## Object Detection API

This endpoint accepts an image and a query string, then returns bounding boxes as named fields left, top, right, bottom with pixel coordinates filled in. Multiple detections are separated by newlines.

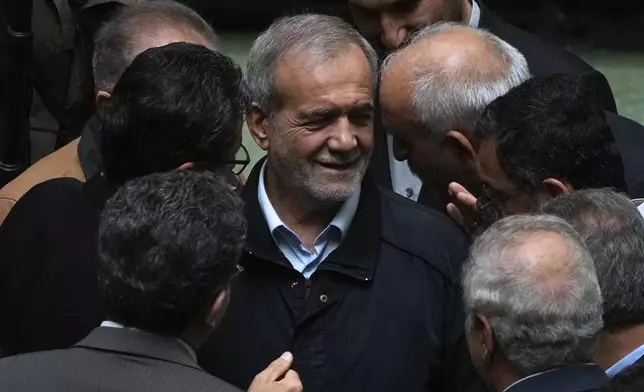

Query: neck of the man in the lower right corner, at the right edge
left=595, top=325, right=644, bottom=370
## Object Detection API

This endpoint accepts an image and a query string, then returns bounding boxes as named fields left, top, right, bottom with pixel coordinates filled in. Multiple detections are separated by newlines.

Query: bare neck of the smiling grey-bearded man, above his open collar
left=264, top=166, right=342, bottom=247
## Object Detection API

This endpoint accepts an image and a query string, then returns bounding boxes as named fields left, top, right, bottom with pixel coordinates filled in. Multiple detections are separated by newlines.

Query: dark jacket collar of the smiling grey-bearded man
left=242, top=158, right=382, bottom=281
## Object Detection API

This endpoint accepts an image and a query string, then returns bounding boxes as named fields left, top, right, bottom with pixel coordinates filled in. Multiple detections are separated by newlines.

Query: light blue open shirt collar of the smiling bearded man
left=257, top=163, right=360, bottom=279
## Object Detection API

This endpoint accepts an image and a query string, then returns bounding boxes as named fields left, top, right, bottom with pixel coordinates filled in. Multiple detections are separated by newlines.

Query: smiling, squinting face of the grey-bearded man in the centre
left=260, top=47, right=374, bottom=201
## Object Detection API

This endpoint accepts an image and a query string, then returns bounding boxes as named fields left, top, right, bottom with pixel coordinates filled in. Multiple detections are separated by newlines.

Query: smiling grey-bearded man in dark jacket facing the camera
left=201, top=14, right=484, bottom=392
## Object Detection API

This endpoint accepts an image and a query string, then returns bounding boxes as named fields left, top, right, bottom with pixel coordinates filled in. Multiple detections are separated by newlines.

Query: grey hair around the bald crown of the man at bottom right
left=463, top=215, right=602, bottom=375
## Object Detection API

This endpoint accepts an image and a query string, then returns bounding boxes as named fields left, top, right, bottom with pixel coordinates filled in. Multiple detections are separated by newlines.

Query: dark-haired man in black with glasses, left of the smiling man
left=0, top=43, right=249, bottom=363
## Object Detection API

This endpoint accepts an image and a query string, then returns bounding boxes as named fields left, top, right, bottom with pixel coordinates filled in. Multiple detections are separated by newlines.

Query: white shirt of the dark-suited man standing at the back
left=387, top=0, right=481, bottom=201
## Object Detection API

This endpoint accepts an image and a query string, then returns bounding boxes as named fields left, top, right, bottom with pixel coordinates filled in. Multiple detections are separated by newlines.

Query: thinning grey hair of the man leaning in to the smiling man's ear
left=383, top=22, right=531, bottom=141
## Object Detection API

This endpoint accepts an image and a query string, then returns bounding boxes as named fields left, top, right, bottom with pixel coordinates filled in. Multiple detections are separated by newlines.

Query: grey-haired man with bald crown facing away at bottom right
left=463, top=215, right=606, bottom=392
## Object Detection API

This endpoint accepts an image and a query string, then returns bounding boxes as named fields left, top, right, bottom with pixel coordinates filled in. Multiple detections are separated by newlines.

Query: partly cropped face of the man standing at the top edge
left=349, top=0, right=463, bottom=50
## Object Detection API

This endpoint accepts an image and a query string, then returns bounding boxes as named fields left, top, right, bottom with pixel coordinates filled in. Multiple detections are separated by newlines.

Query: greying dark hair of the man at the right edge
left=542, top=189, right=644, bottom=331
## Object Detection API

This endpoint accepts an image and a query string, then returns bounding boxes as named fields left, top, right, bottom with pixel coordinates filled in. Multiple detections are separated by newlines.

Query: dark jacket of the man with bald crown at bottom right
left=505, top=363, right=608, bottom=392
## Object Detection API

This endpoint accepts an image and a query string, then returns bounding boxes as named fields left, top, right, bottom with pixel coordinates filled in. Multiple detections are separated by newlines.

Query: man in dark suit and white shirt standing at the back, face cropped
left=349, top=0, right=617, bottom=200
